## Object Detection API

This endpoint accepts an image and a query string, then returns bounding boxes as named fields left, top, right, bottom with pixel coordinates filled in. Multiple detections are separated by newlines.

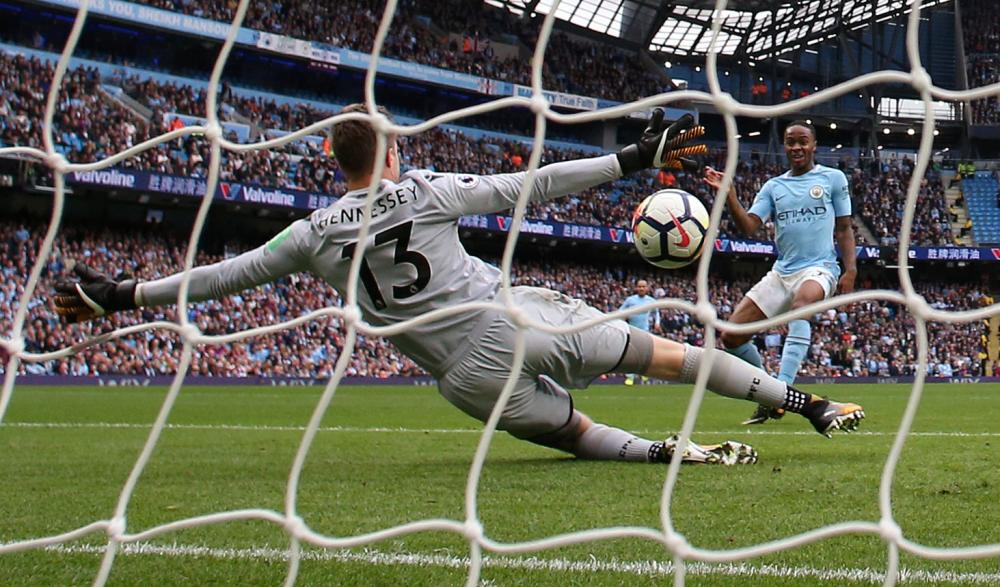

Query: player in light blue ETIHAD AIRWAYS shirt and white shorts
left=705, top=120, right=860, bottom=424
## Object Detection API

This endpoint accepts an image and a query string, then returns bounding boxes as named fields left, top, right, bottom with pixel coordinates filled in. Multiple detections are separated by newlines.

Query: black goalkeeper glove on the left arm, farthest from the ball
left=55, top=263, right=139, bottom=322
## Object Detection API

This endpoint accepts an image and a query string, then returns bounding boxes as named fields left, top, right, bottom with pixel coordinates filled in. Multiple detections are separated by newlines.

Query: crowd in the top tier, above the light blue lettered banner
left=129, top=0, right=671, bottom=102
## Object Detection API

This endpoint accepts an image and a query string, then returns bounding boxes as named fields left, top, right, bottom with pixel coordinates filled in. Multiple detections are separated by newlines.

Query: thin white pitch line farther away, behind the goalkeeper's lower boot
left=0, top=422, right=1000, bottom=438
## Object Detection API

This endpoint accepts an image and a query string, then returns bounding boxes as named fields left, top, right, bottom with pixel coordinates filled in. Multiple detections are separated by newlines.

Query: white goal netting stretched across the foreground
left=0, top=0, right=1000, bottom=585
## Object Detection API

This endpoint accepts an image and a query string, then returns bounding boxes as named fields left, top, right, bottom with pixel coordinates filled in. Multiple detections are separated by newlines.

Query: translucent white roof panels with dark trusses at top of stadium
left=485, top=0, right=950, bottom=59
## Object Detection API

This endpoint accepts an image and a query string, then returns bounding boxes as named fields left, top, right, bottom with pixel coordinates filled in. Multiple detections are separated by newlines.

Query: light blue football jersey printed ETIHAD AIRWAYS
left=749, top=165, right=851, bottom=277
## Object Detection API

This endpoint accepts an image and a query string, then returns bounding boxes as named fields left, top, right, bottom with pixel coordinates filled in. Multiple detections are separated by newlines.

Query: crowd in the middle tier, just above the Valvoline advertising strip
left=0, top=54, right=953, bottom=250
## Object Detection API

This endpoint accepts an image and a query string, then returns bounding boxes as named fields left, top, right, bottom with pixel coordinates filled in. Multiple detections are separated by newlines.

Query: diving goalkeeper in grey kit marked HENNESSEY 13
left=55, top=104, right=864, bottom=464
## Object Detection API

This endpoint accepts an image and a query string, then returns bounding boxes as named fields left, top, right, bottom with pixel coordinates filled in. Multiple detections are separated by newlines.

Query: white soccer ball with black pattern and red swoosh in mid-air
left=632, top=189, right=709, bottom=269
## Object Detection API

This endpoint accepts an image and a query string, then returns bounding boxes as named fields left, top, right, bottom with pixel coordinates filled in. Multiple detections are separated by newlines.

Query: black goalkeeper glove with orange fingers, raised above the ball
left=618, top=108, right=708, bottom=175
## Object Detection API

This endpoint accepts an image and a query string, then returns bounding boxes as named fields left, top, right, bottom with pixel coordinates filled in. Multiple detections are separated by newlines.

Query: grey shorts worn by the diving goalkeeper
left=438, top=287, right=630, bottom=438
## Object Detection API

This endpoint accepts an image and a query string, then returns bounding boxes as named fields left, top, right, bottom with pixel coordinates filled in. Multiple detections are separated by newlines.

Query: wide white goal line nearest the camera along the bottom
left=31, top=543, right=1000, bottom=585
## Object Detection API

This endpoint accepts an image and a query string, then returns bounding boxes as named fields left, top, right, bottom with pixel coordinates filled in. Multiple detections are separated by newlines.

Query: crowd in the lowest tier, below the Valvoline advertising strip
left=0, top=221, right=988, bottom=377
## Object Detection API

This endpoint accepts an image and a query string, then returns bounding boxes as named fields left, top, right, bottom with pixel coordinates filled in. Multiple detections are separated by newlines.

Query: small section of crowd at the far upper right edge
left=962, top=0, right=1000, bottom=125
